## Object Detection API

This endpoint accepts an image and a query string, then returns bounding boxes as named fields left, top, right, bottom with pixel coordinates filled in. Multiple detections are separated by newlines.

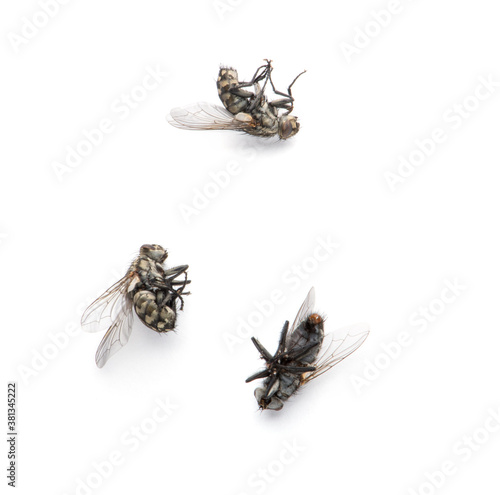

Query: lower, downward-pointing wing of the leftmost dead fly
left=95, top=296, right=133, bottom=368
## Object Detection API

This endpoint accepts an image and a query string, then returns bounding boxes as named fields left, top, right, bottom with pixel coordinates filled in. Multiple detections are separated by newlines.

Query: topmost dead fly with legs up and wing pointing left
left=167, top=60, right=305, bottom=139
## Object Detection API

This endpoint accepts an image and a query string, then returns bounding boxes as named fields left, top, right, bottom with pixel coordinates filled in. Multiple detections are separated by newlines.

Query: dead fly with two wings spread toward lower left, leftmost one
left=82, top=244, right=191, bottom=368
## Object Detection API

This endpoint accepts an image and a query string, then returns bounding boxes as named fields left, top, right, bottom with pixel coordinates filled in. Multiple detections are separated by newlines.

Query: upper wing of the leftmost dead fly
left=81, top=273, right=135, bottom=332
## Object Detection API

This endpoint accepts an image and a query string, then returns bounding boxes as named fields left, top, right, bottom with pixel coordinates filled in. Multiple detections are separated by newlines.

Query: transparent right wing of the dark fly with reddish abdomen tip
left=303, top=323, right=370, bottom=383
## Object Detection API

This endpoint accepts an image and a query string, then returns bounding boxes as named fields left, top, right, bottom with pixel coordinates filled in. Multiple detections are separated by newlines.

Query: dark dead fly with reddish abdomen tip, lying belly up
left=246, top=288, right=369, bottom=411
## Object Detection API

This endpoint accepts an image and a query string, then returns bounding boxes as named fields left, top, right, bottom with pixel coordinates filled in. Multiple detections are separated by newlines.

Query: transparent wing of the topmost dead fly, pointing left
left=167, top=102, right=253, bottom=131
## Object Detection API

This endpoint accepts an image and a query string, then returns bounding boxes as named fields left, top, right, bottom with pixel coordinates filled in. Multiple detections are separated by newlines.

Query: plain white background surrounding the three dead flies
left=0, top=0, right=500, bottom=495
